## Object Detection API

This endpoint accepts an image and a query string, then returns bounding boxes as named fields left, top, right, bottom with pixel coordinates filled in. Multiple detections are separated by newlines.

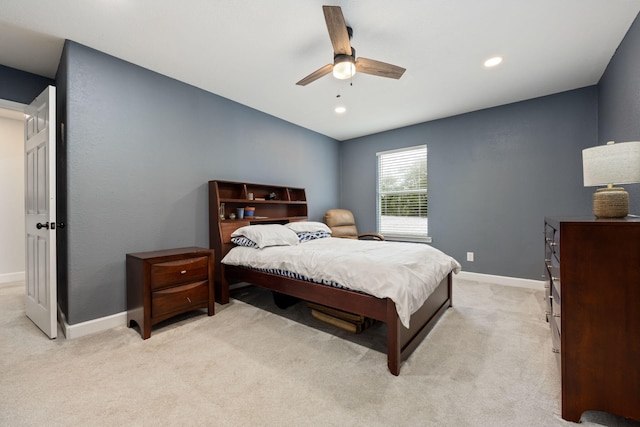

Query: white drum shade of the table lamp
left=582, top=141, right=640, bottom=187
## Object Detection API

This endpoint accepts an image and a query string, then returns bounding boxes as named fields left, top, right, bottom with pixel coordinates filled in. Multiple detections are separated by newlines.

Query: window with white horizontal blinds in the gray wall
left=377, top=145, right=431, bottom=242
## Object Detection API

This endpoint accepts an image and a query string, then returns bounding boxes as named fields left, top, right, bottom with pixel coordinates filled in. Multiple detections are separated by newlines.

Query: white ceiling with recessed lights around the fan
left=0, top=0, right=640, bottom=140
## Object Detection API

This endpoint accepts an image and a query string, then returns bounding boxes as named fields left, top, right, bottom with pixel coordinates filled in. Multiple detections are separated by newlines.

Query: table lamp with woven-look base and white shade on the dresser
left=582, top=141, right=640, bottom=218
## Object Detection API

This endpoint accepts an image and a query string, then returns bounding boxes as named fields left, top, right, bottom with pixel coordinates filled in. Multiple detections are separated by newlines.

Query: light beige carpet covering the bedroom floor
left=0, top=280, right=636, bottom=426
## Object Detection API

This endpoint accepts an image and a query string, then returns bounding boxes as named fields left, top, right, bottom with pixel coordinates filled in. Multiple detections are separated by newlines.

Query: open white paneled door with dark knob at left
left=24, top=86, right=58, bottom=338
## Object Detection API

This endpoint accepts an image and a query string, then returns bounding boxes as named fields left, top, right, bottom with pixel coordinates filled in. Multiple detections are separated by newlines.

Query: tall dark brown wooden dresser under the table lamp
left=545, top=218, right=640, bottom=422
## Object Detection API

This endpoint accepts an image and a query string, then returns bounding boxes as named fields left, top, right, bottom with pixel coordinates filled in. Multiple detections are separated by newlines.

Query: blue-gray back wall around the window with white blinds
left=340, top=86, right=597, bottom=279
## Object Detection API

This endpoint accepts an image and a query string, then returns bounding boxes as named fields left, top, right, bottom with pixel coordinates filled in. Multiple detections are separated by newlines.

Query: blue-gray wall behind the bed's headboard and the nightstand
left=58, top=42, right=339, bottom=324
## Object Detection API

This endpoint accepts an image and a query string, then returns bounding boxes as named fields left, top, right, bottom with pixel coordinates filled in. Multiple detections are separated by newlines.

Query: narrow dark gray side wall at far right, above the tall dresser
left=598, top=15, right=640, bottom=215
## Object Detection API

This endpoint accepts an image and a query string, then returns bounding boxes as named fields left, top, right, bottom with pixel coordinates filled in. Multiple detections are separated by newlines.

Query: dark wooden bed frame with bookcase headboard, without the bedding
left=209, top=181, right=452, bottom=375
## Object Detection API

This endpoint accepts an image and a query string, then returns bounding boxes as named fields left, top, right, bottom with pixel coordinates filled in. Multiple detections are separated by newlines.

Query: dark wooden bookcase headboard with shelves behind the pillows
left=209, top=180, right=308, bottom=303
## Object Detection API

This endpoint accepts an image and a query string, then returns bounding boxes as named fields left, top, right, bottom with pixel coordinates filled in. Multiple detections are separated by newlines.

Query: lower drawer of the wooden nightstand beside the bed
left=151, top=280, right=209, bottom=318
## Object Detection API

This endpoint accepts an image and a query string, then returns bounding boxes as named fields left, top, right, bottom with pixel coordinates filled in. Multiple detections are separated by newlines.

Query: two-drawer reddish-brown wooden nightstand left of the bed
left=127, top=247, right=215, bottom=339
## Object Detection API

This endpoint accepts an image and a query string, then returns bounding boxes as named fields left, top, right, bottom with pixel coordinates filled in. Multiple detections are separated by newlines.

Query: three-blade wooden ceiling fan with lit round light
left=296, top=6, right=405, bottom=86
